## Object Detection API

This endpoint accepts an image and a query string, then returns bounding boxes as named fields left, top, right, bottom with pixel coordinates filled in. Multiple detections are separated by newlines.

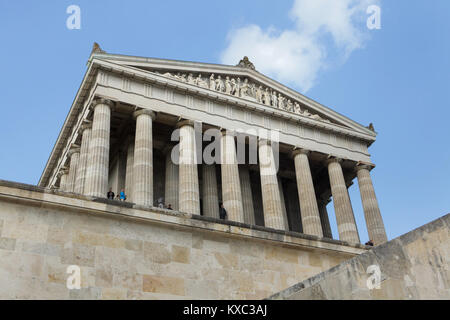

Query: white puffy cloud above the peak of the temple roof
left=221, top=0, right=378, bottom=92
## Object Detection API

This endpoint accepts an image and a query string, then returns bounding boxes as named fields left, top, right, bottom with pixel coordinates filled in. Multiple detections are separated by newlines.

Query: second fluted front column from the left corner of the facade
left=133, top=109, right=155, bottom=206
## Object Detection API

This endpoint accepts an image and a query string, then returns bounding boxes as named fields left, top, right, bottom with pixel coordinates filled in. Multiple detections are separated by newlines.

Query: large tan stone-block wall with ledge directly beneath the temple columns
left=0, top=180, right=367, bottom=299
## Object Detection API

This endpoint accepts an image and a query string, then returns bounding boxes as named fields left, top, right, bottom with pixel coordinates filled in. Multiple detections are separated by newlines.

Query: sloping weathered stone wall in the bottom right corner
left=270, top=214, right=450, bottom=300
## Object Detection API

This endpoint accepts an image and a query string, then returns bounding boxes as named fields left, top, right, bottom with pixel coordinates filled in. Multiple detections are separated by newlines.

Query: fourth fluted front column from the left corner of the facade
left=220, top=130, right=244, bottom=222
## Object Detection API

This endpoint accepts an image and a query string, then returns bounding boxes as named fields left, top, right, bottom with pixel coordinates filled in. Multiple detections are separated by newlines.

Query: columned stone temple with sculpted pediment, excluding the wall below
left=39, top=45, right=387, bottom=245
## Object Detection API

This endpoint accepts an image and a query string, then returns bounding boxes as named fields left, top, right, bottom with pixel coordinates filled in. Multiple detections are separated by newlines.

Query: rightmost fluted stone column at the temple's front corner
left=356, top=164, right=387, bottom=245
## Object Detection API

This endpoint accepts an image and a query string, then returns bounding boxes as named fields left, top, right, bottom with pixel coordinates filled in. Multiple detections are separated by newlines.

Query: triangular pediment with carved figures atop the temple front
left=91, top=52, right=376, bottom=136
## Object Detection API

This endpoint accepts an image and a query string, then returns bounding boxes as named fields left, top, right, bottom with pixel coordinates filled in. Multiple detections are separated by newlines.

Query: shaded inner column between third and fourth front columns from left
left=202, top=163, right=219, bottom=219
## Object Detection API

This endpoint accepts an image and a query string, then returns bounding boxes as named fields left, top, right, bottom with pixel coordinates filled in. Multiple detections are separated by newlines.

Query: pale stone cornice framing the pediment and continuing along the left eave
left=38, top=52, right=376, bottom=186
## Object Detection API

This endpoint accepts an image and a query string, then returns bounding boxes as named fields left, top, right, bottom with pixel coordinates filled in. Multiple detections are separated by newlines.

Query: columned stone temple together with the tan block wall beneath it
left=0, top=44, right=394, bottom=299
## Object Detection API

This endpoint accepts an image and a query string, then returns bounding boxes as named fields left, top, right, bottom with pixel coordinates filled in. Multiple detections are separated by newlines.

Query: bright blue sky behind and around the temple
left=0, top=0, right=450, bottom=242
